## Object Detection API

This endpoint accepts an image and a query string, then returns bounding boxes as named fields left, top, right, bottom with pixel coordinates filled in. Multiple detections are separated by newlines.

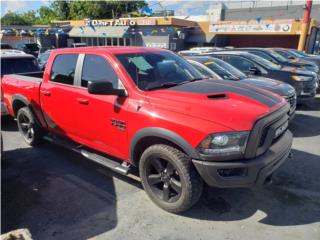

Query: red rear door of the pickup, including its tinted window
left=40, top=54, right=79, bottom=138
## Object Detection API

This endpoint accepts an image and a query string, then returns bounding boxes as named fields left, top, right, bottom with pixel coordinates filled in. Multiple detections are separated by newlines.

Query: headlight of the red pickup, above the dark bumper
left=198, top=132, right=249, bottom=156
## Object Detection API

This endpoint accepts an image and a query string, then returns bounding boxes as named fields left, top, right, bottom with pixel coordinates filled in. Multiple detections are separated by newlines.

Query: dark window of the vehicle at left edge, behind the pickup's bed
left=1, top=58, right=40, bottom=75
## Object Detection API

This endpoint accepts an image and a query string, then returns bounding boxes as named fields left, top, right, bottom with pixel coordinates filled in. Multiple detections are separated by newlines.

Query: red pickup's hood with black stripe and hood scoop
left=147, top=79, right=285, bottom=131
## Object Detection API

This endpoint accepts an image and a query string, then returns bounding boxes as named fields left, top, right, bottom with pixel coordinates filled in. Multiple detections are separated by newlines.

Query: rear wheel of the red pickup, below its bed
left=17, top=107, right=43, bottom=146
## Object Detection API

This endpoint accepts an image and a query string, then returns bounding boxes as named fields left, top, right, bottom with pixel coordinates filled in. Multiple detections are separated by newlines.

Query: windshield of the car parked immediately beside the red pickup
left=203, top=59, right=246, bottom=80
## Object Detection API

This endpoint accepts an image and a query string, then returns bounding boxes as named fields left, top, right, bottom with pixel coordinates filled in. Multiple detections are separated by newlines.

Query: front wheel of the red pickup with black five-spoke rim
left=139, top=144, right=203, bottom=213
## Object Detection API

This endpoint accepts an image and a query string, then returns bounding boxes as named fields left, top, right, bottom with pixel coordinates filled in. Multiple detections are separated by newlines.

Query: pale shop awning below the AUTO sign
left=69, top=26, right=129, bottom=38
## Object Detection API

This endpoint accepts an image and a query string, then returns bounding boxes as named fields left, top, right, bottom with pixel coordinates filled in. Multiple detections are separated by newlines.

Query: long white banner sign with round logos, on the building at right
left=209, top=23, right=292, bottom=33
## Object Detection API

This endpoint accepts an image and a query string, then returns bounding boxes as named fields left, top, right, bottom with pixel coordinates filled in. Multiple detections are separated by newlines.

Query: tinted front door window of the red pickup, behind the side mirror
left=81, top=55, right=119, bottom=88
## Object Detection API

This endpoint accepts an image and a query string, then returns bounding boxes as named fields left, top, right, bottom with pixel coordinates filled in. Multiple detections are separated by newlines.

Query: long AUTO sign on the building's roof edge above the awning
left=84, top=18, right=156, bottom=27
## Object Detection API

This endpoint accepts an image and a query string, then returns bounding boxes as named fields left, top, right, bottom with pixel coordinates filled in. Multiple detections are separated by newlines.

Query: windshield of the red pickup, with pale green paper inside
left=115, top=51, right=203, bottom=91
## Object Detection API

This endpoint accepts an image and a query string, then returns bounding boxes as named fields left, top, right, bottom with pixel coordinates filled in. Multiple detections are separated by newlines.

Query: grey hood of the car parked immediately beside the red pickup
left=240, top=77, right=295, bottom=96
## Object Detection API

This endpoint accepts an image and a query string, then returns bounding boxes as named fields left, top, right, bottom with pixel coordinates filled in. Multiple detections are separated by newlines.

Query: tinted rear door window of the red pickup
left=50, top=54, right=78, bottom=85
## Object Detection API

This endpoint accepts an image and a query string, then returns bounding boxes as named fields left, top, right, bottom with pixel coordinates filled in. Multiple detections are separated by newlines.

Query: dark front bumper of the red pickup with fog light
left=192, top=130, right=292, bottom=188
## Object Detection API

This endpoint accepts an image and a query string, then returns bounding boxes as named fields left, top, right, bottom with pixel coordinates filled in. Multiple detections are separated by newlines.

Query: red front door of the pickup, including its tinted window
left=74, top=54, right=128, bottom=158
